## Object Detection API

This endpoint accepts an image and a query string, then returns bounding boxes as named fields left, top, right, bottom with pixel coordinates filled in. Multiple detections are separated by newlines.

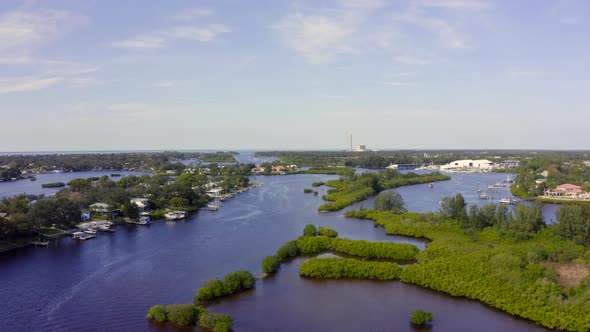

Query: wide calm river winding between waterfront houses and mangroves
left=0, top=175, right=552, bottom=331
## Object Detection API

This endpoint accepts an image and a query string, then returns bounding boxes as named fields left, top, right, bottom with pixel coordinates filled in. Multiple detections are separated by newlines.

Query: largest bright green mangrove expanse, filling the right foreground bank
left=347, top=200, right=590, bottom=331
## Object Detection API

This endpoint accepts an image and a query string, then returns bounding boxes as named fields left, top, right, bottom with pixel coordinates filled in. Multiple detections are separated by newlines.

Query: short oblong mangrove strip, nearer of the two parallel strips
left=299, top=258, right=402, bottom=280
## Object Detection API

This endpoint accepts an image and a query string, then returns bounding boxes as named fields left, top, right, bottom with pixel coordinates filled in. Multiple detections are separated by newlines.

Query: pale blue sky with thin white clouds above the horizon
left=0, top=0, right=590, bottom=151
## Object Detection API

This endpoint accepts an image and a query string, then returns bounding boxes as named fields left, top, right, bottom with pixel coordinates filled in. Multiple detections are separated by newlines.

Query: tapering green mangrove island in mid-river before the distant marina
left=319, top=169, right=451, bottom=212
